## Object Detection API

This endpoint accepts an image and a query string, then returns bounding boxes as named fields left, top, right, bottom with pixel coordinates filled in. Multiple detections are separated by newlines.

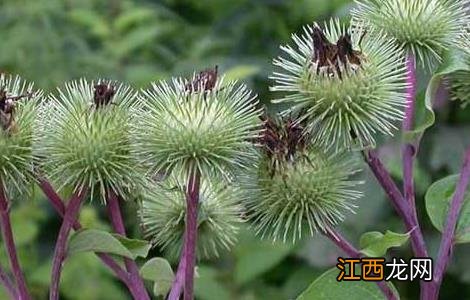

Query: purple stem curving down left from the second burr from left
left=49, top=187, right=87, bottom=300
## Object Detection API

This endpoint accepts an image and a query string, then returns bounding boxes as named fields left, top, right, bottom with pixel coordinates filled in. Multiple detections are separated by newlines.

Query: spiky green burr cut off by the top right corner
left=352, top=0, right=470, bottom=69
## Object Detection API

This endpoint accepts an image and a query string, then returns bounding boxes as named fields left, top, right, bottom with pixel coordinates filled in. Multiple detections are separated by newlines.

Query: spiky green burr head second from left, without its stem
left=40, top=79, right=143, bottom=201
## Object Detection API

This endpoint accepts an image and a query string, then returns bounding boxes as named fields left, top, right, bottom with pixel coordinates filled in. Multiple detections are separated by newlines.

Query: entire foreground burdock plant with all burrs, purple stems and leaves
left=0, top=0, right=470, bottom=300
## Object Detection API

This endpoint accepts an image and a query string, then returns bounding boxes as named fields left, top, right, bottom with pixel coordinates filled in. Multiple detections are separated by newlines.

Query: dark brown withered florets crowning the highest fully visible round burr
left=312, top=26, right=365, bottom=79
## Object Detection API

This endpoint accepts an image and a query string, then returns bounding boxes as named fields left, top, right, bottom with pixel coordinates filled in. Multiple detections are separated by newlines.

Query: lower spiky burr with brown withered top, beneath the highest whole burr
left=241, top=119, right=361, bottom=242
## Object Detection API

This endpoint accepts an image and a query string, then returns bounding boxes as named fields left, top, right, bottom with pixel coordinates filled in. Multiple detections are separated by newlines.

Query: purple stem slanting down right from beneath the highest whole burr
left=365, top=150, right=428, bottom=257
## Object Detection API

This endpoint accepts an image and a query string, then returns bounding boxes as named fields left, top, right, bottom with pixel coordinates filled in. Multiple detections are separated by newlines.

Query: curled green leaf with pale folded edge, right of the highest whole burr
left=403, top=49, right=468, bottom=145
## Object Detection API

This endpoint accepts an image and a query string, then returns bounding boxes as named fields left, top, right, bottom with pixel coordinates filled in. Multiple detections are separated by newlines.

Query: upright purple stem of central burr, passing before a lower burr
left=180, top=170, right=200, bottom=300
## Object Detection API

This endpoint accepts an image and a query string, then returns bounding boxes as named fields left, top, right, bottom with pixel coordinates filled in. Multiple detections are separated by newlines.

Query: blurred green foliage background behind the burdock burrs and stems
left=0, top=0, right=470, bottom=300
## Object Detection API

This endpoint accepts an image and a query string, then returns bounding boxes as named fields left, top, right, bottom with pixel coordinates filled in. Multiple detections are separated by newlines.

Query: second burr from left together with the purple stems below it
left=39, top=80, right=148, bottom=299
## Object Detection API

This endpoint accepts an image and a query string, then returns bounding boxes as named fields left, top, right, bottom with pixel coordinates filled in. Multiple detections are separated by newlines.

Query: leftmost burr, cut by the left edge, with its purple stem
left=0, top=74, right=42, bottom=299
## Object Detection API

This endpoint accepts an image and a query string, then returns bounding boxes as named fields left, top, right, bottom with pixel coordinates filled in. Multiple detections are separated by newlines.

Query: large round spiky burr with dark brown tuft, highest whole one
left=272, top=20, right=406, bottom=149
